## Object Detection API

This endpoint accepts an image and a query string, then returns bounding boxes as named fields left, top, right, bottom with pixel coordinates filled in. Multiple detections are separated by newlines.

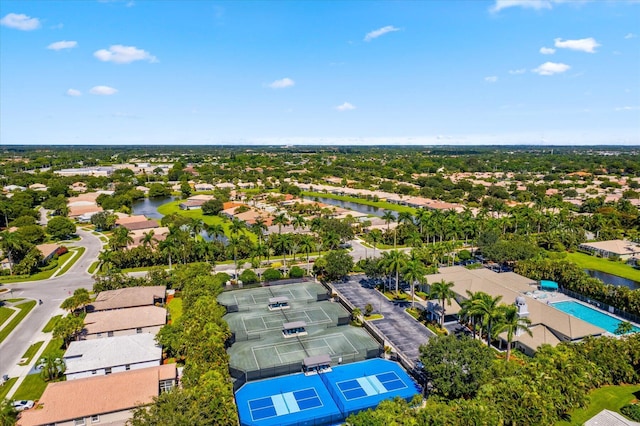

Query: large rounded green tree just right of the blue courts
left=420, top=335, right=494, bottom=399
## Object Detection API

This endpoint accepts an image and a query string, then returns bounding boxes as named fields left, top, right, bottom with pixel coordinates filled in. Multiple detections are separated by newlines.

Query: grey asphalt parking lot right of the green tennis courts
left=333, top=275, right=434, bottom=361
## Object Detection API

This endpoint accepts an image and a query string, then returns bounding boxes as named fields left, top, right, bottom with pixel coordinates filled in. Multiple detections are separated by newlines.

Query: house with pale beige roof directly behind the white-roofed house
left=82, top=306, right=167, bottom=340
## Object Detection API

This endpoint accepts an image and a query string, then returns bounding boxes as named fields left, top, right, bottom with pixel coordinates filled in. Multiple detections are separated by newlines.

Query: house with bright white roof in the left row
left=63, top=333, right=162, bottom=380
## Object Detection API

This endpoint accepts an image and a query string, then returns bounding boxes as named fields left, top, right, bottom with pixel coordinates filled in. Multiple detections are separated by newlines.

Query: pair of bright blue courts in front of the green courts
left=236, top=359, right=421, bottom=426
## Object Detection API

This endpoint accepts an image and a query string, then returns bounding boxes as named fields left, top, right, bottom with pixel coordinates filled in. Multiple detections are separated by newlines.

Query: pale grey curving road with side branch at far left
left=0, top=228, right=102, bottom=377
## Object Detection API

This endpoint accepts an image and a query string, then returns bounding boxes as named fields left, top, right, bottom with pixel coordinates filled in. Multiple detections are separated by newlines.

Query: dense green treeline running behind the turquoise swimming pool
left=515, top=259, right=640, bottom=316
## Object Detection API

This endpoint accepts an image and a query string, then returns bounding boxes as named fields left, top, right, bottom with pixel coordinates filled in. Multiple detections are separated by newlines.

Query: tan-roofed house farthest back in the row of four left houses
left=87, top=285, right=167, bottom=312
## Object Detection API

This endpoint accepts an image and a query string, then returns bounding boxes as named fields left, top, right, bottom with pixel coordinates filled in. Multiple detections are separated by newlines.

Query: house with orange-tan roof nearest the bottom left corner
left=17, top=364, right=178, bottom=426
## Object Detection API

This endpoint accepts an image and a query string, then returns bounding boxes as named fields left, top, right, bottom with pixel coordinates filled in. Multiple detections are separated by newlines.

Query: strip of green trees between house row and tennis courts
left=130, top=264, right=238, bottom=426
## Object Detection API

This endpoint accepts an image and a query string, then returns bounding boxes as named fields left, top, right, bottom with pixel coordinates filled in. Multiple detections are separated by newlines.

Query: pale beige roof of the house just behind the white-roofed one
left=84, top=306, right=167, bottom=334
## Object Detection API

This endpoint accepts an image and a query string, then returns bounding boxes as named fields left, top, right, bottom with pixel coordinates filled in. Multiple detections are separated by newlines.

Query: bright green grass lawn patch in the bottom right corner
left=557, top=385, right=640, bottom=426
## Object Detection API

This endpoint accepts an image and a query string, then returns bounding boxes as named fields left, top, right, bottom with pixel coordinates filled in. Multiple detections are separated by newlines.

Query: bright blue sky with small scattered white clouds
left=0, top=0, right=640, bottom=145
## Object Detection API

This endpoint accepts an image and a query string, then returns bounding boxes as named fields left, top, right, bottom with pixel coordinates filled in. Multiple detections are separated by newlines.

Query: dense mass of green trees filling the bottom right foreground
left=347, top=334, right=640, bottom=426
